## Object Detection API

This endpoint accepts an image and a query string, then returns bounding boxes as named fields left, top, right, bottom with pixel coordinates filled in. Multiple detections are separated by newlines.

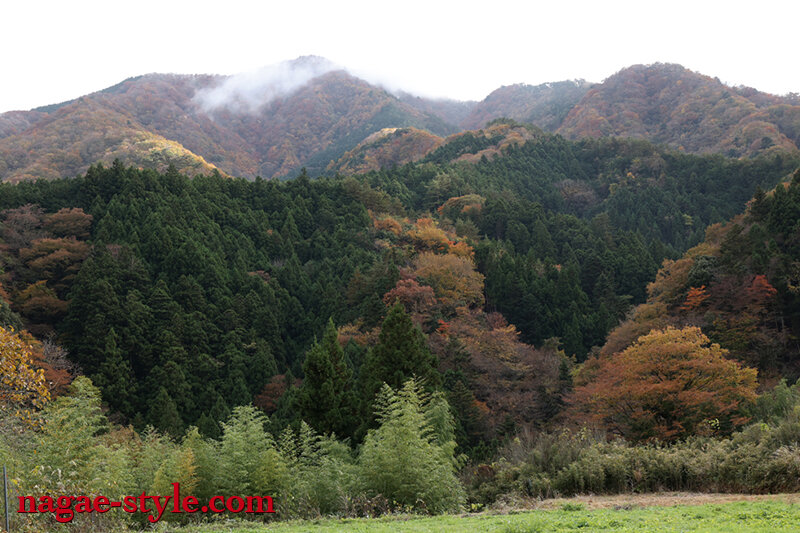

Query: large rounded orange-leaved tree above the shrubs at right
left=569, top=327, right=757, bottom=441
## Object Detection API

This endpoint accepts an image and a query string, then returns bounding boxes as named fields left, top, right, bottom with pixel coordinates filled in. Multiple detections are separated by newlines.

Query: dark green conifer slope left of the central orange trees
left=3, top=165, right=384, bottom=432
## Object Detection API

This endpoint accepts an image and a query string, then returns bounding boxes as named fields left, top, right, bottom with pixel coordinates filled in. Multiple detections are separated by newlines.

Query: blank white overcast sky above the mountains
left=0, top=0, right=800, bottom=112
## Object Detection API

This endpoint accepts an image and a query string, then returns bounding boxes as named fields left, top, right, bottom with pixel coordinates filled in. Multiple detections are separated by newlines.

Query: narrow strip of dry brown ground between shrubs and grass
left=525, top=492, right=800, bottom=509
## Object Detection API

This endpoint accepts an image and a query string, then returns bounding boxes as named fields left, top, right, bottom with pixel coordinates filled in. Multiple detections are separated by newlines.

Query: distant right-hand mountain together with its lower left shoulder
left=459, top=63, right=800, bottom=157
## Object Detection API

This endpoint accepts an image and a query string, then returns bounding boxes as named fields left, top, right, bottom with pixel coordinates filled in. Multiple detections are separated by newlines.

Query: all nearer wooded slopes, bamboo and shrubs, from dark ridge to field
left=0, top=141, right=800, bottom=530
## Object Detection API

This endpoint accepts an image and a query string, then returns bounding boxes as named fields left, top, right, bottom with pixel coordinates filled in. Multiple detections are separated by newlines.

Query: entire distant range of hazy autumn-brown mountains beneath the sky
left=0, top=57, right=800, bottom=181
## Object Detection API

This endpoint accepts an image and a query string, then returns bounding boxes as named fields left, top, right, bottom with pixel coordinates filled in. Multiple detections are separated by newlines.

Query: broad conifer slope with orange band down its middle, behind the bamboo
left=0, top=122, right=797, bottom=440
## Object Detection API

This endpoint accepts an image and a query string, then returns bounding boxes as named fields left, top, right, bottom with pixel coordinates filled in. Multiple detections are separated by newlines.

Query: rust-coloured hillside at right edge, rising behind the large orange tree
left=601, top=171, right=800, bottom=383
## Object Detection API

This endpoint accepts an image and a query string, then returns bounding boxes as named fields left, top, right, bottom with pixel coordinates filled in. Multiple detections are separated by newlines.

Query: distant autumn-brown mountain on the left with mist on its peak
left=0, top=58, right=459, bottom=181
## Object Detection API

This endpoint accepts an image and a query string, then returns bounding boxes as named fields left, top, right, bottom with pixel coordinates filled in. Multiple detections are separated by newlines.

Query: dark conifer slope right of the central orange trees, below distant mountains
left=365, top=128, right=798, bottom=356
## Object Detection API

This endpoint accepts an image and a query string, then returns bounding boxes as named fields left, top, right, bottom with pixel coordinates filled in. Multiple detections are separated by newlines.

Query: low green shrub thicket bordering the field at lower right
left=462, top=384, right=800, bottom=504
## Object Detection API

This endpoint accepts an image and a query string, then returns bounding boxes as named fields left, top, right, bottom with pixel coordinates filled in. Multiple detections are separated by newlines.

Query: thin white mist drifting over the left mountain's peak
left=194, top=56, right=340, bottom=112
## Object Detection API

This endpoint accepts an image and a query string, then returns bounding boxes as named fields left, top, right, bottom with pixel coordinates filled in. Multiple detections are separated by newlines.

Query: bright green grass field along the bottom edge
left=156, top=500, right=800, bottom=533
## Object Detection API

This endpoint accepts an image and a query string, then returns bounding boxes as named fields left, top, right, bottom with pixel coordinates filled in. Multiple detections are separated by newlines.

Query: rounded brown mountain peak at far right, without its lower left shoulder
left=557, top=63, right=800, bottom=157
